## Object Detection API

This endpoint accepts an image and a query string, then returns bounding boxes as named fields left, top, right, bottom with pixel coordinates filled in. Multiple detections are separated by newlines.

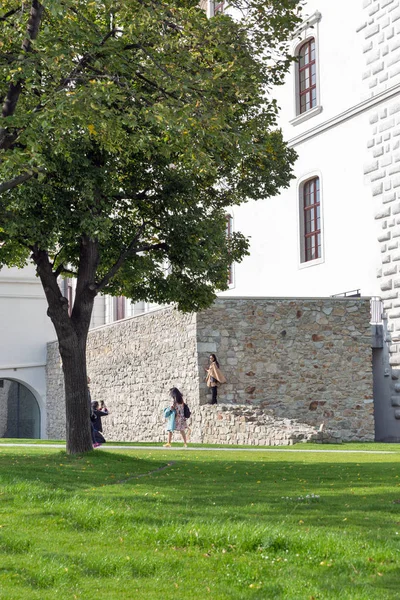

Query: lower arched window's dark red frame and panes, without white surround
left=300, top=177, right=322, bottom=262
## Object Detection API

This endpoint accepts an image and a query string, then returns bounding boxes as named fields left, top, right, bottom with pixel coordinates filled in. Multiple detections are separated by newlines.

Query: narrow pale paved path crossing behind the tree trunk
left=0, top=443, right=400, bottom=454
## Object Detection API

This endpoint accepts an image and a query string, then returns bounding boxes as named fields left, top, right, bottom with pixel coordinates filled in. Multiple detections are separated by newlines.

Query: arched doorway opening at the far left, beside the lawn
left=0, top=379, right=40, bottom=439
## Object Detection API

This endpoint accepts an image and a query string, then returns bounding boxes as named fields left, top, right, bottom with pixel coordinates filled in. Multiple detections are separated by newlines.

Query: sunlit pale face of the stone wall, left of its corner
left=47, top=308, right=199, bottom=441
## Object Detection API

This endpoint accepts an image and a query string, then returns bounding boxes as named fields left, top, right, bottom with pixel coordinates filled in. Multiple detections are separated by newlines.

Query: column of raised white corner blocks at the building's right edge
left=357, top=0, right=400, bottom=366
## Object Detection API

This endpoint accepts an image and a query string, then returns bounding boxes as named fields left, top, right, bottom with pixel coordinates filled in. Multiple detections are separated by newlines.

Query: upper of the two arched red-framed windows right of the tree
left=298, top=38, right=317, bottom=114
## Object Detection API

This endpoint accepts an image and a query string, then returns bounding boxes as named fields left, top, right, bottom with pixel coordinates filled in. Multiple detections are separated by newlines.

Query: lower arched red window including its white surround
left=299, top=176, right=322, bottom=265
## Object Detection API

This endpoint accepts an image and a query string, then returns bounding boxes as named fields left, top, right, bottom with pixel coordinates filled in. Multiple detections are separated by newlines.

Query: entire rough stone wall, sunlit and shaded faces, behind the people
left=47, top=298, right=374, bottom=445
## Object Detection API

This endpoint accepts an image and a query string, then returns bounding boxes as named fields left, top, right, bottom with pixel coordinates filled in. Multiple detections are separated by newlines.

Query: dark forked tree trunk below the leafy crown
left=32, top=238, right=98, bottom=454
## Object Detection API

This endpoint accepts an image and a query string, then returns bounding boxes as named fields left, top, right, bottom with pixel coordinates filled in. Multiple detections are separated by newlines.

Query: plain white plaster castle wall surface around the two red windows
left=223, top=0, right=386, bottom=296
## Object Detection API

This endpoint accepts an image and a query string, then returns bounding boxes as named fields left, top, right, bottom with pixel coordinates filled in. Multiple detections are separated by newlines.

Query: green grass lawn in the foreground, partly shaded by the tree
left=0, top=444, right=400, bottom=600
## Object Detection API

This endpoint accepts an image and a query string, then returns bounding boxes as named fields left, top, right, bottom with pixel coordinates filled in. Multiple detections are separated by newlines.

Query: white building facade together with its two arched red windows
left=222, top=0, right=390, bottom=296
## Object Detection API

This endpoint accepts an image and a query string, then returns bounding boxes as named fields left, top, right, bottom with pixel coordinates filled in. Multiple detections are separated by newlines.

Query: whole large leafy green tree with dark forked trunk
left=0, top=0, right=299, bottom=453
